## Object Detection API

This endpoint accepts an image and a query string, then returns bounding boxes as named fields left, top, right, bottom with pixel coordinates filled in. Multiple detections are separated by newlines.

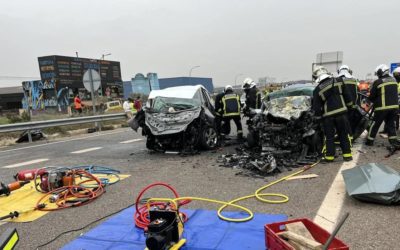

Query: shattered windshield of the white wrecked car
left=153, top=96, right=201, bottom=112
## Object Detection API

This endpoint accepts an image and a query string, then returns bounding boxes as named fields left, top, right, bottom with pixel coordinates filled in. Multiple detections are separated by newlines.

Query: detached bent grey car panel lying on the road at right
left=342, top=163, right=400, bottom=205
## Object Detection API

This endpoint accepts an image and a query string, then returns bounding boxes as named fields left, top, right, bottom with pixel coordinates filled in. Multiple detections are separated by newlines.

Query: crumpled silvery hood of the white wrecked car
left=145, top=107, right=201, bottom=135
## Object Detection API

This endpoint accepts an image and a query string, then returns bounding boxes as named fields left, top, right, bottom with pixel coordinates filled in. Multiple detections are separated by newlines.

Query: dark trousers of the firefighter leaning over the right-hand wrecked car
left=323, top=114, right=352, bottom=160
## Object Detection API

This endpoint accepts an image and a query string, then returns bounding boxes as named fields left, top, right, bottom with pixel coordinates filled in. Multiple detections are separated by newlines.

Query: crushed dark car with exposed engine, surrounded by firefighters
left=242, top=84, right=368, bottom=167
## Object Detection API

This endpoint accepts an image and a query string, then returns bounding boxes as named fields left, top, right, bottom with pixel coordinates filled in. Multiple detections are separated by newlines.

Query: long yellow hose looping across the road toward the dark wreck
left=147, top=161, right=319, bottom=222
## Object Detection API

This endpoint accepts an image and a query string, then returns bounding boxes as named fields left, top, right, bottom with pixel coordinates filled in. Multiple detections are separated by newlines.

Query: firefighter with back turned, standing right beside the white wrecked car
left=221, top=85, right=243, bottom=140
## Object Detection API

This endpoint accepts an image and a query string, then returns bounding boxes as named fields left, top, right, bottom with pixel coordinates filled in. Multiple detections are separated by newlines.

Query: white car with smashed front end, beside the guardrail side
left=129, top=85, right=217, bottom=152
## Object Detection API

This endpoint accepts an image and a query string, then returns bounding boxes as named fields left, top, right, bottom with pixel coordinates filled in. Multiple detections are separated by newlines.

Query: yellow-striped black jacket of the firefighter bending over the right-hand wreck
left=312, top=77, right=351, bottom=117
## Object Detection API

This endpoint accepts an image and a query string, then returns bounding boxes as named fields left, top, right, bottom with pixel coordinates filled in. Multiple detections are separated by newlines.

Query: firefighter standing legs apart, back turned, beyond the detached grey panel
left=365, top=64, right=399, bottom=146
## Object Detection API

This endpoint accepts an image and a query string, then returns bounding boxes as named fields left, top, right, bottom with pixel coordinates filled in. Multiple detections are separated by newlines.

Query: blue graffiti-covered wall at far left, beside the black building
left=22, top=80, right=69, bottom=111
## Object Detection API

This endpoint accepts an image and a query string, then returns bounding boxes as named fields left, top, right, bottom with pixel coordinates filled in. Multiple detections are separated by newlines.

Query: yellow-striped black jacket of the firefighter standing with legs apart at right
left=369, top=76, right=399, bottom=111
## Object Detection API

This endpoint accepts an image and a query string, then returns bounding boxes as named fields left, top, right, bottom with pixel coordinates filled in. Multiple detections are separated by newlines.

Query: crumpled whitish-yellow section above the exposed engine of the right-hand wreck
left=264, top=96, right=311, bottom=120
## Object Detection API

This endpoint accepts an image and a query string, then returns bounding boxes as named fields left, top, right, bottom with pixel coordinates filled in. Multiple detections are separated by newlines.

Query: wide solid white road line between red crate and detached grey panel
left=314, top=144, right=362, bottom=232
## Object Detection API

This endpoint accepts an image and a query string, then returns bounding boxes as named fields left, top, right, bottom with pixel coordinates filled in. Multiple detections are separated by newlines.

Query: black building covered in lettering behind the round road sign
left=38, top=55, right=122, bottom=99
